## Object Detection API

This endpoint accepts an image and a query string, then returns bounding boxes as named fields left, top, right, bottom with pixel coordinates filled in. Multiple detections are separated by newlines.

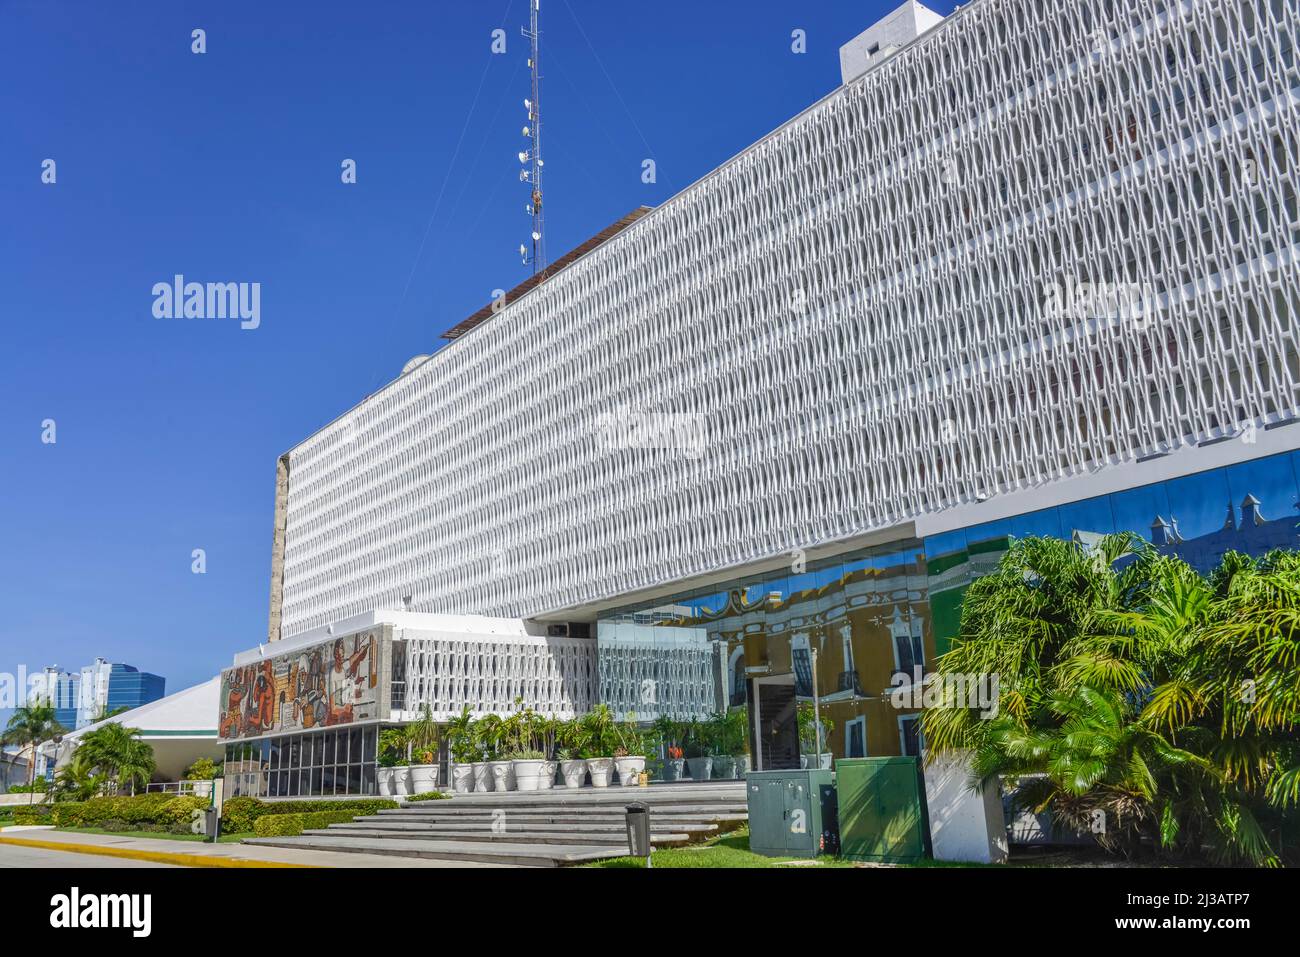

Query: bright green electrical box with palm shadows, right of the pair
left=835, top=758, right=930, bottom=863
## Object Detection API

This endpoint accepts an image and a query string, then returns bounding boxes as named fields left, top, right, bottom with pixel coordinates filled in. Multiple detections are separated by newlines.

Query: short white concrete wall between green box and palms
left=924, top=757, right=1008, bottom=863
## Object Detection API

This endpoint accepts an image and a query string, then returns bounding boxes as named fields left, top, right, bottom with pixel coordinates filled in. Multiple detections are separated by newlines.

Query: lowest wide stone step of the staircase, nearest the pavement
left=243, top=835, right=620, bottom=867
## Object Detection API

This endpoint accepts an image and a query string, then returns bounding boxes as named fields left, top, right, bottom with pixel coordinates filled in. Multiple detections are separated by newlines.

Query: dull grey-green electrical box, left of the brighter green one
left=745, top=770, right=835, bottom=857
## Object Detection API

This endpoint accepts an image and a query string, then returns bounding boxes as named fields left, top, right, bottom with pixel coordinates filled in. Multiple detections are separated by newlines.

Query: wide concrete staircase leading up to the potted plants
left=244, top=781, right=749, bottom=867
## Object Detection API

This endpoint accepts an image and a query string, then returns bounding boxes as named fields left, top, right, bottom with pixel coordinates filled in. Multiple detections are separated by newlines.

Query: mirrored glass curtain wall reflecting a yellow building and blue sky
left=597, top=452, right=1300, bottom=758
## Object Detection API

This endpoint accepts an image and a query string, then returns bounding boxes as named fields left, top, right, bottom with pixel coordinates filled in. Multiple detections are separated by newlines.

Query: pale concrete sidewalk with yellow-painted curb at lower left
left=0, top=828, right=514, bottom=867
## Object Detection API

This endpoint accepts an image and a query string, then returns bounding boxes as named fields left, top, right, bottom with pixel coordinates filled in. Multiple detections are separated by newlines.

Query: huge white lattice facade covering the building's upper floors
left=281, top=0, right=1300, bottom=642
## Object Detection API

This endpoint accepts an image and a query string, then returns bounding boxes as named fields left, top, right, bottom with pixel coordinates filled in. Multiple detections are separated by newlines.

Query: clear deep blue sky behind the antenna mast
left=0, top=0, right=953, bottom=718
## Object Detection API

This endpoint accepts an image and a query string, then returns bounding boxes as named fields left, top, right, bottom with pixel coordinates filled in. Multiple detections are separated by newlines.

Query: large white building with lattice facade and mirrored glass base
left=222, top=0, right=1300, bottom=790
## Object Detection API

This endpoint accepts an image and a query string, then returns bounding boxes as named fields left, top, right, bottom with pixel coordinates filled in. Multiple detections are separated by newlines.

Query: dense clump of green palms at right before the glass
left=923, top=536, right=1300, bottom=865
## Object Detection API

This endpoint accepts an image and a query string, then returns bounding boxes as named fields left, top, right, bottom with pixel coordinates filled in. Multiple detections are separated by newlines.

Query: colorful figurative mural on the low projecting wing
left=217, top=632, right=381, bottom=740
